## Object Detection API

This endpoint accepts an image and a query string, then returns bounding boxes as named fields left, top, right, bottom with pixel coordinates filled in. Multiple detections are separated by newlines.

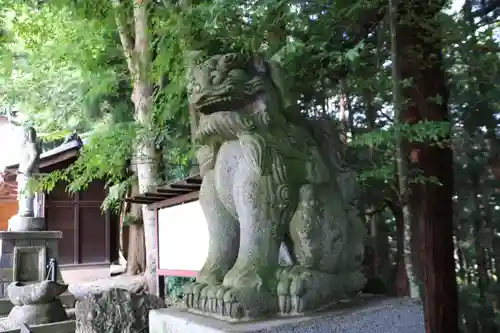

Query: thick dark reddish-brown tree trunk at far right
left=397, top=0, right=458, bottom=333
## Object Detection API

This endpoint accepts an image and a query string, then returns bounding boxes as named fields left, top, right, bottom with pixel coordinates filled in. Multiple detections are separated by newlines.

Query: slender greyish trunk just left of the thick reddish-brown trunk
left=389, top=0, right=420, bottom=298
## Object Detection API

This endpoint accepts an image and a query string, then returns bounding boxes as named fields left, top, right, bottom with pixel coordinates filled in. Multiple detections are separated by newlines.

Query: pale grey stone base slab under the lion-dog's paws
left=149, top=297, right=425, bottom=333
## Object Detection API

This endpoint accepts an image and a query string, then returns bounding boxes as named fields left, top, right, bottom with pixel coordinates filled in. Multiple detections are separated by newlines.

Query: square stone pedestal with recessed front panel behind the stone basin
left=0, top=231, right=62, bottom=298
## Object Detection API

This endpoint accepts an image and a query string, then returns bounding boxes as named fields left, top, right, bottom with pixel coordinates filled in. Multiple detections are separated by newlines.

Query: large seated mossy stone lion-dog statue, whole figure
left=185, top=54, right=365, bottom=321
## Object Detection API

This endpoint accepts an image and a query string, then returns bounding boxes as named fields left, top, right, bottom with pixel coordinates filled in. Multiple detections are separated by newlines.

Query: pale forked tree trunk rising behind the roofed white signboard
left=113, top=0, right=158, bottom=293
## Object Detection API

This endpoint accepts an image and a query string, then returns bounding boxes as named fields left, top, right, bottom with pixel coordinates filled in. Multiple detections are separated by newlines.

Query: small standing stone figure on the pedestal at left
left=17, top=127, right=40, bottom=217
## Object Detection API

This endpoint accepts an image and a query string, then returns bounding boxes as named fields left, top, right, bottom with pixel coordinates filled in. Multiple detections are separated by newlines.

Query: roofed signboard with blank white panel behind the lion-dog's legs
left=125, top=175, right=204, bottom=297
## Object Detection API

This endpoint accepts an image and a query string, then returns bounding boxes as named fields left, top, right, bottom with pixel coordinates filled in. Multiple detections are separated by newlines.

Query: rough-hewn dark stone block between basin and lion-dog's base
left=75, top=289, right=165, bottom=333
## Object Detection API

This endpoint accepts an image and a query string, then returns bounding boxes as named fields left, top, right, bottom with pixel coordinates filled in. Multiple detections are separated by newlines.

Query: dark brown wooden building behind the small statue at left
left=4, top=139, right=119, bottom=268
